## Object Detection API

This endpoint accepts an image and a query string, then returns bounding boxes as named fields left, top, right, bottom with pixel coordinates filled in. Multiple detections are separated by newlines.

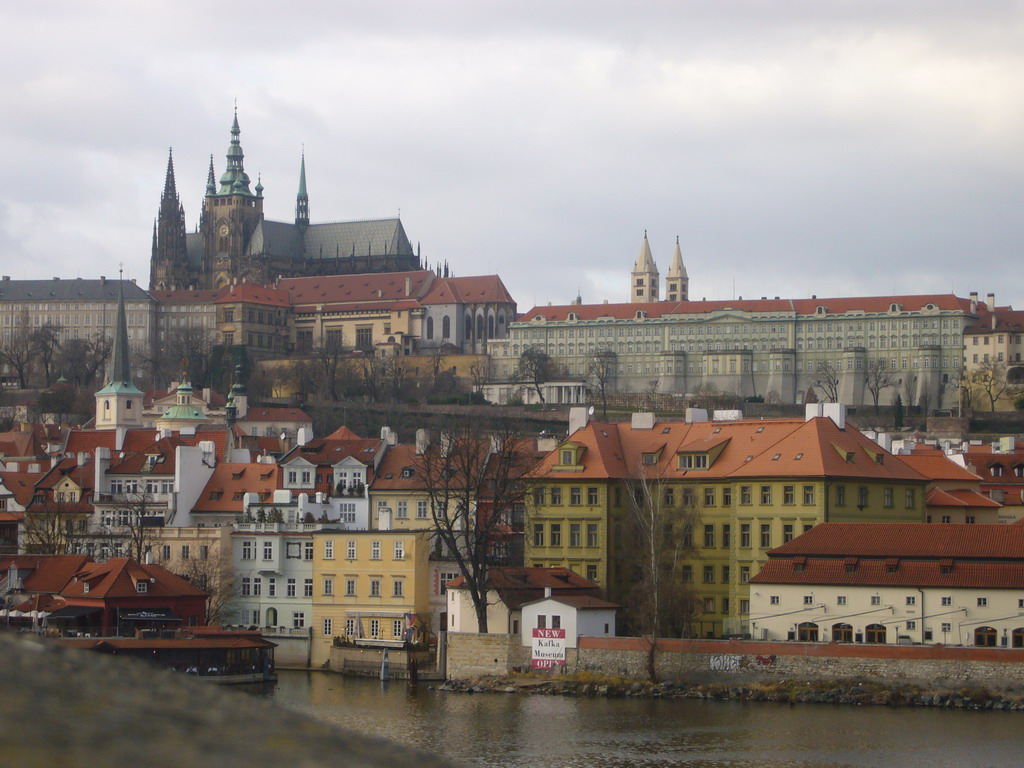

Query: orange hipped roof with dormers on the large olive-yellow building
left=532, top=417, right=925, bottom=481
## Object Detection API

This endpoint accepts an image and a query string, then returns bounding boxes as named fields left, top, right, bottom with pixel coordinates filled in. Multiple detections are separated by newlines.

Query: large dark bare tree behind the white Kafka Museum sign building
left=415, top=419, right=532, bottom=633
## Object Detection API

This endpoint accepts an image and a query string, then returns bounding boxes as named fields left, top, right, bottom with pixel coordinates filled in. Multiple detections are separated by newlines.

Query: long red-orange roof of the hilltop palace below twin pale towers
left=519, top=294, right=971, bottom=322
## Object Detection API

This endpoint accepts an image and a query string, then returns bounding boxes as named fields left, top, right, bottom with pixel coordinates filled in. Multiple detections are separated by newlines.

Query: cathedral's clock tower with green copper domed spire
left=200, top=109, right=263, bottom=288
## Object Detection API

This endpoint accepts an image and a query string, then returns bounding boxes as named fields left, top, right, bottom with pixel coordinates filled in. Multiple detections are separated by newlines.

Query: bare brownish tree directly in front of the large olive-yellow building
left=625, top=479, right=698, bottom=637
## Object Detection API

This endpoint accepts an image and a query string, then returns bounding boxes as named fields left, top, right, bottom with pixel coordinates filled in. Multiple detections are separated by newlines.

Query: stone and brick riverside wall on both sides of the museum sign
left=447, top=634, right=1024, bottom=691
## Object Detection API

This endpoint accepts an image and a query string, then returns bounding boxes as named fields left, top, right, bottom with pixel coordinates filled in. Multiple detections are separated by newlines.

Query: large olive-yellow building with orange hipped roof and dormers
left=525, top=415, right=927, bottom=637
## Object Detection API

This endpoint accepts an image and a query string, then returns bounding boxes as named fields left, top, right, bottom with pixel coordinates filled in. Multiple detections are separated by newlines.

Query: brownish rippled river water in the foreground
left=264, top=670, right=1024, bottom=768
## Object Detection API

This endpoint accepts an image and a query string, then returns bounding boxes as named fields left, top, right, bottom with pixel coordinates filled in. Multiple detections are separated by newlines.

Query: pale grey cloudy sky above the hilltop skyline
left=0, top=0, right=1024, bottom=310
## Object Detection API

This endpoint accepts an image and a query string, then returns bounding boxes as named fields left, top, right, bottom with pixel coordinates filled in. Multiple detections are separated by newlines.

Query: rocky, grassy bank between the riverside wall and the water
left=440, top=675, right=1024, bottom=712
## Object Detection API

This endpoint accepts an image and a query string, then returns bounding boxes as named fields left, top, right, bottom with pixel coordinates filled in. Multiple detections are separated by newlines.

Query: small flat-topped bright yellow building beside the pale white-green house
left=312, top=530, right=429, bottom=667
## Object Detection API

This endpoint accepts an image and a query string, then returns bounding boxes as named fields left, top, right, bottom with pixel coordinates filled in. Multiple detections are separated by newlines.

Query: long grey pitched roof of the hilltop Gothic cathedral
left=249, top=218, right=415, bottom=259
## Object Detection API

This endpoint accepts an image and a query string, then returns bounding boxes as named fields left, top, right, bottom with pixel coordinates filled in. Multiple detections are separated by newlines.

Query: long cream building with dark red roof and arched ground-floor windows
left=751, top=523, right=1024, bottom=648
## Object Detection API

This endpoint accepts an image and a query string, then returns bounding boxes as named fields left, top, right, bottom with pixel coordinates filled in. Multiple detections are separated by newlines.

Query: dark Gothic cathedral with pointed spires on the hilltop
left=150, top=113, right=420, bottom=291
